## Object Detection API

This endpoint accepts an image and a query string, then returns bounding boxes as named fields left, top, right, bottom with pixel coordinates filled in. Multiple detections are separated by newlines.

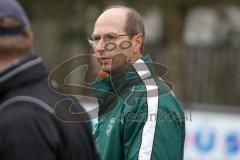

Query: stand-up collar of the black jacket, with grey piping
left=0, top=54, right=48, bottom=94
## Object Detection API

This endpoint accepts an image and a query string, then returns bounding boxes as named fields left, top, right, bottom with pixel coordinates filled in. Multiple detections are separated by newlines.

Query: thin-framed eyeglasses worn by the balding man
left=88, top=34, right=135, bottom=47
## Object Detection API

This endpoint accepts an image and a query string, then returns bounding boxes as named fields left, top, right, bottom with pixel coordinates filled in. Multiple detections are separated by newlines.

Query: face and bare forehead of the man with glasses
left=92, top=8, right=133, bottom=73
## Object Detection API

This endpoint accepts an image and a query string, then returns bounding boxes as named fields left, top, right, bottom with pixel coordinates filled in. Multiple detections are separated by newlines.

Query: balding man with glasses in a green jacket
left=89, top=6, right=185, bottom=160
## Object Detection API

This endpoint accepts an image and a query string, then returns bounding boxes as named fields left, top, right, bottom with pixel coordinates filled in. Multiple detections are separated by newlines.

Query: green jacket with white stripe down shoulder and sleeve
left=93, top=55, right=185, bottom=160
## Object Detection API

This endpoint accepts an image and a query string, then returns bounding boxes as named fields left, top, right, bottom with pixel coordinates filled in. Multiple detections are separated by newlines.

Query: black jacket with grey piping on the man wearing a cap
left=0, top=55, right=98, bottom=160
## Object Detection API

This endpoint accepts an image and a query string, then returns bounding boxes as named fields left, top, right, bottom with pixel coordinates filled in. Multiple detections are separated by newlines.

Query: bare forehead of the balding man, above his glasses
left=93, top=8, right=127, bottom=35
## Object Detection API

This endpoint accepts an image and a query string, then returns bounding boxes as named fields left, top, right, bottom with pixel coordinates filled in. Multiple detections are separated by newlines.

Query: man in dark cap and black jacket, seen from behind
left=0, top=0, right=99, bottom=160
